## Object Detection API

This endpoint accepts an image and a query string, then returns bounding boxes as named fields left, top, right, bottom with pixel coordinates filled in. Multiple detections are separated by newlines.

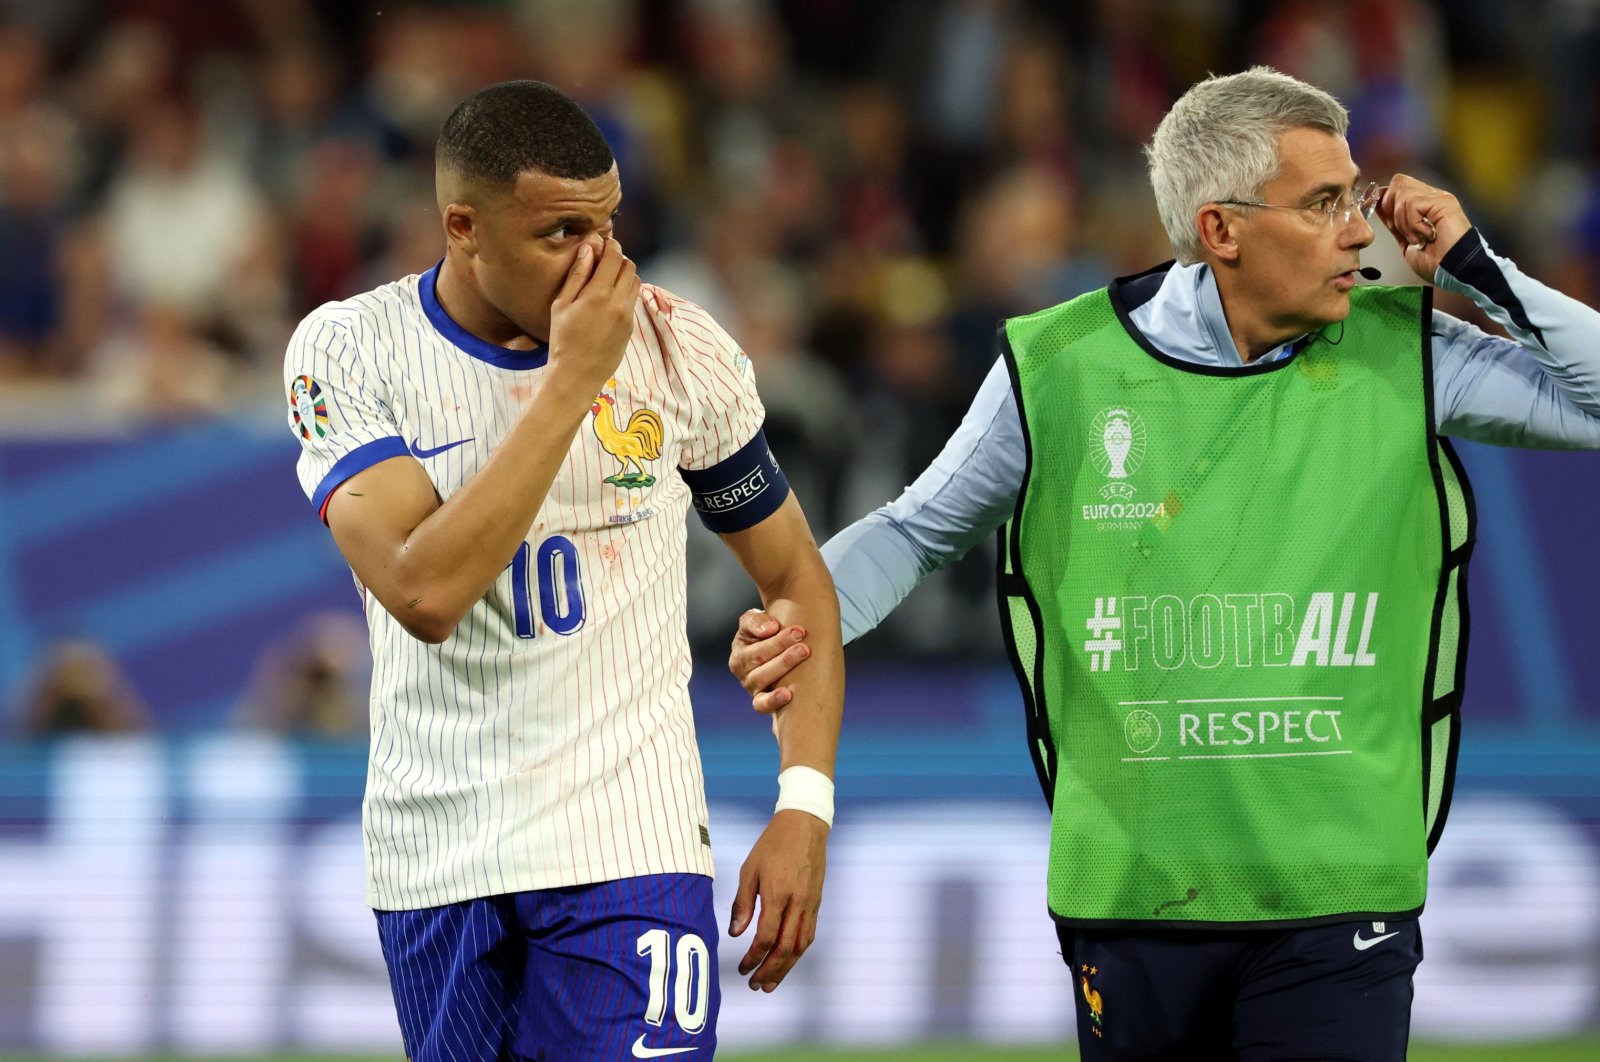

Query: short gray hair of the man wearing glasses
left=1144, top=66, right=1350, bottom=266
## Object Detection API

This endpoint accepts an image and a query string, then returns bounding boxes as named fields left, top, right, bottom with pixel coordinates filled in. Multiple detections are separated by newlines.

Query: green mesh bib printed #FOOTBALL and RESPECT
left=1006, top=288, right=1466, bottom=924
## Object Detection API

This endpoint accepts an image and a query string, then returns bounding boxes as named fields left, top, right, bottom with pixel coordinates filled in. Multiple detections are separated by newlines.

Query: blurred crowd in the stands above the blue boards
left=9, top=0, right=1600, bottom=726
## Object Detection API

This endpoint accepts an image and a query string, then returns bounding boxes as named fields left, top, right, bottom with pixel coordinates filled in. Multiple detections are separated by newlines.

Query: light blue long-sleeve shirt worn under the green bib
left=822, top=229, right=1600, bottom=641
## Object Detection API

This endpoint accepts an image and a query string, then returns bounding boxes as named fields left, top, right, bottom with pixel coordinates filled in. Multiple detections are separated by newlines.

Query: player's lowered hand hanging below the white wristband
left=728, top=809, right=829, bottom=992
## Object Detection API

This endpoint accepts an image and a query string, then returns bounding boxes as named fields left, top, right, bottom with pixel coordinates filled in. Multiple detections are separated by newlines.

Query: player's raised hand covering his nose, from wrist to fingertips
left=550, top=237, right=640, bottom=395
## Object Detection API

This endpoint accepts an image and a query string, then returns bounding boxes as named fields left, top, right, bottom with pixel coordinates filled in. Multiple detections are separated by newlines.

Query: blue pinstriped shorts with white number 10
left=376, top=873, right=722, bottom=1062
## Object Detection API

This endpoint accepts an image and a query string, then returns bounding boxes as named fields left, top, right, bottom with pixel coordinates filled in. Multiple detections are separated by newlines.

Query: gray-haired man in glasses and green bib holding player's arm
left=730, top=67, right=1600, bottom=1062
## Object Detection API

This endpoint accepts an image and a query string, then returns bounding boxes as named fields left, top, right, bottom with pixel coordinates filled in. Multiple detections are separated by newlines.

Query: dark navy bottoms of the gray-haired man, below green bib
left=1056, top=918, right=1422, bottom=1062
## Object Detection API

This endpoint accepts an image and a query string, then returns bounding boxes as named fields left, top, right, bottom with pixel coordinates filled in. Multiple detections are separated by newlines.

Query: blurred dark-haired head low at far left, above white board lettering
left=22, top=641, right=150, bottom=737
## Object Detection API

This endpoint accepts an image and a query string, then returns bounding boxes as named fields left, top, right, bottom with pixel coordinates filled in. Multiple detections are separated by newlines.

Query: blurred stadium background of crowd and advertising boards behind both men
left=0, top=0, right=1600, bottom=1059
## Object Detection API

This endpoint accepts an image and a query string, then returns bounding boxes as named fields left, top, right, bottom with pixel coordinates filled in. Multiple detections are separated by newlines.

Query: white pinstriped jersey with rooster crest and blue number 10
left=285, top=267, right=763, bottom=910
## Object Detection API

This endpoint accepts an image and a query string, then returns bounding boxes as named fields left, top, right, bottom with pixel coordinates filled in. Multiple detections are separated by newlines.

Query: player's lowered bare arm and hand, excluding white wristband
left=722, top=496, right=845, bottom=992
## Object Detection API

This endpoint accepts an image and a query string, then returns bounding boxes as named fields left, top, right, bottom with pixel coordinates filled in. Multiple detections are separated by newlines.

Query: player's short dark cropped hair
left=434, top=82, right=614, bottom=187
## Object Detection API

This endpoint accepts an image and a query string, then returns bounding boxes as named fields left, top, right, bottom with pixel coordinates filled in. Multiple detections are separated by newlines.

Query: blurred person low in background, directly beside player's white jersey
left=238, top=613, right=373, bottom=739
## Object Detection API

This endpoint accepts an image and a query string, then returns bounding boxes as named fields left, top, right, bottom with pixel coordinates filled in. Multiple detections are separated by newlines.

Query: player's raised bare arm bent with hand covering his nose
left=326, top=237, right=640, bottom=641
